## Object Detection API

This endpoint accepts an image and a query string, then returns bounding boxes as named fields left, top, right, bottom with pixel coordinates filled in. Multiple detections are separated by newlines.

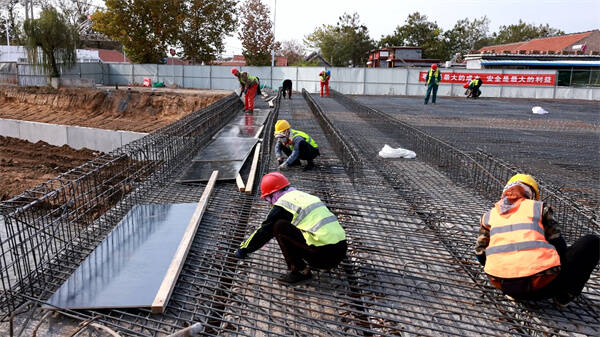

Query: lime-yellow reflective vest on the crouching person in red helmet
left=275, top=190, right=346, bottom=246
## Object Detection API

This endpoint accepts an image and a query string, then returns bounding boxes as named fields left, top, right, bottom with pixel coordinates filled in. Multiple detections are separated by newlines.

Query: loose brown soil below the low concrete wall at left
left=0, top=137, right=98, bottom=201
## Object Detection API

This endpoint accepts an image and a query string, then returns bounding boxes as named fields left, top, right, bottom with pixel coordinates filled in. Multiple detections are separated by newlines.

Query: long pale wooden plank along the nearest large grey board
left=151, top=171, right=219, bottom=314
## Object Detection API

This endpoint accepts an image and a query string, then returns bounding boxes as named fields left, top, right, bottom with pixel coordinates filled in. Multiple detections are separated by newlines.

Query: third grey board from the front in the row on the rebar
left=192, top=137, right=257, bottom=162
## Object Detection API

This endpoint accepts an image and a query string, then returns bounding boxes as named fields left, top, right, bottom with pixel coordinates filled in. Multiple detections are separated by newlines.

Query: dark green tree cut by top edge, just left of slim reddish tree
left=179, top=0, right=237, bottom=63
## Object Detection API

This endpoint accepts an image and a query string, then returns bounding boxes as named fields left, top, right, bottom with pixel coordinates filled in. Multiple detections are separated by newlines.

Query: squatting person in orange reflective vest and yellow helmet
left=475, top=174, right=600, bottom=306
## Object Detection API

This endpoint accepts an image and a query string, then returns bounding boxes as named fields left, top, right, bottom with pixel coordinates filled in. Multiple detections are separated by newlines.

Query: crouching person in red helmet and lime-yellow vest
left=235, top=172, right=347, bottom=285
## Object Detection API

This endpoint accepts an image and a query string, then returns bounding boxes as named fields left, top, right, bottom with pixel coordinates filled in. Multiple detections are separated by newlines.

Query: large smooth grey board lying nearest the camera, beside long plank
left=44, top=203, right=197, bottom=309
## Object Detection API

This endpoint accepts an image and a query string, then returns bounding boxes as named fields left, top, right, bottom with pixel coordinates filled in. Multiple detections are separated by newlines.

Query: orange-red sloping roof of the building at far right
left=478, top=31, right=593, bottom=54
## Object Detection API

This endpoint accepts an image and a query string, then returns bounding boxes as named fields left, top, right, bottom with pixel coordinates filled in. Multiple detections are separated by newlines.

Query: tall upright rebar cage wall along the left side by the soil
left=0, top=94, right=241, bottom=317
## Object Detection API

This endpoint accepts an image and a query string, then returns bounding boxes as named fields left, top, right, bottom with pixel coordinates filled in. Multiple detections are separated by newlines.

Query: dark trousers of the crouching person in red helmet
left=273, top=220, right=348, bottom=271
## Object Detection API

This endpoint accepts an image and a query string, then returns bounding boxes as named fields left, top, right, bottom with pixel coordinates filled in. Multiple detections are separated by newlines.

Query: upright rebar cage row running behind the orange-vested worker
left=332, top=90, right=600, bottom=242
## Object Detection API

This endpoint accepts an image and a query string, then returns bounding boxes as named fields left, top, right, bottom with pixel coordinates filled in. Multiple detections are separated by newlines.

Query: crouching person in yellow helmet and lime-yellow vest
left=274, top=119, right=320, bottom=171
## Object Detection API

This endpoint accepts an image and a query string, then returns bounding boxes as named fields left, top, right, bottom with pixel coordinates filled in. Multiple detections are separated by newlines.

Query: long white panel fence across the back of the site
left=1, top=63, right=600, bottom=100
